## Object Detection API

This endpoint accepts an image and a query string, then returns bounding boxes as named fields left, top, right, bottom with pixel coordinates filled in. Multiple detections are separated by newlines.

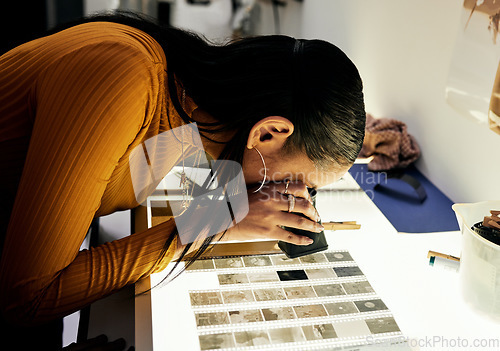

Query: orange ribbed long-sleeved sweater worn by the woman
left=0, top=22, right=196, bottom=323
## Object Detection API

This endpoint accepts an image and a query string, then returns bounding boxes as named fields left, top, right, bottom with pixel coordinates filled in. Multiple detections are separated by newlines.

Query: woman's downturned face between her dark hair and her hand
left=243, top=149, right=349, bottom=188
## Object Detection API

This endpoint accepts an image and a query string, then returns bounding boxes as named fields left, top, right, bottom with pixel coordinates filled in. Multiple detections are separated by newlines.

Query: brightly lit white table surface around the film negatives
left=136, top=175, right=500, bottom=351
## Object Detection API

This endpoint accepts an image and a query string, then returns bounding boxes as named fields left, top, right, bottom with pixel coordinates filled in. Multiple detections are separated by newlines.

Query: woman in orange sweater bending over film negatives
left=0, top=14, right=365, bottom=350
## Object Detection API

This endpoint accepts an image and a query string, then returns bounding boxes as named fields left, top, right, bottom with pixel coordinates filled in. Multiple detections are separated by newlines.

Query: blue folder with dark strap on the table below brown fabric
left=349, top=164, right=459, bottom=233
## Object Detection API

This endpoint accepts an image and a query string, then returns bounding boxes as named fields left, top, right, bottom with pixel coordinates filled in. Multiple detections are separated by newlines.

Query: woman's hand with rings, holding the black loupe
left=222, top=182, right=324, bottom=245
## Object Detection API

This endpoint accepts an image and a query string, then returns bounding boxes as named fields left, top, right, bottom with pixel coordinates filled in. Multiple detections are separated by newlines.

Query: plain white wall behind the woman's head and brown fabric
left=302, top=0, right=500, bottom=202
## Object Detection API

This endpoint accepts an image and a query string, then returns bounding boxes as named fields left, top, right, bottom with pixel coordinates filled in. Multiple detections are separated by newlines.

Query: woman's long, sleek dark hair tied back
left=51, top=12, right=365, bottom=288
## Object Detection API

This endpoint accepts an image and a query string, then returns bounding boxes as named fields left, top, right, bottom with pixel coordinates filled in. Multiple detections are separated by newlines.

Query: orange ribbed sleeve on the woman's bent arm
left=0, top=28, right=180, bottom=324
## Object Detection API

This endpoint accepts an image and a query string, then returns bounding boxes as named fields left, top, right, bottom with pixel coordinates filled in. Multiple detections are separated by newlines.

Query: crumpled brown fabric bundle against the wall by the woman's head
left=359, top=114, right=420, bottom=171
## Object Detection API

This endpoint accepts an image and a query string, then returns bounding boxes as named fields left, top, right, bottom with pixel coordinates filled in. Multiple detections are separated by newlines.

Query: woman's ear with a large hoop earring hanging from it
left=247, top=116, right=294, bottom=153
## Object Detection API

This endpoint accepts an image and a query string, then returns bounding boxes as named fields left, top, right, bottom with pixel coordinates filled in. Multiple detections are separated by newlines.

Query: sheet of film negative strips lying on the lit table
left=184, top=250, right=404, bottom=350
